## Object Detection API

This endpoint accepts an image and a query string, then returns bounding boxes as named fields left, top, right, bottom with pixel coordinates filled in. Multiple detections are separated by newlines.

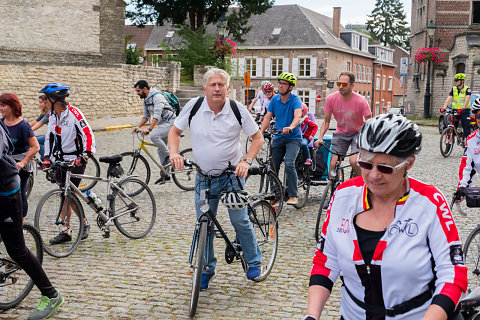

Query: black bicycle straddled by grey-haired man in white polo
left=189, top=164, right=278, bottom=318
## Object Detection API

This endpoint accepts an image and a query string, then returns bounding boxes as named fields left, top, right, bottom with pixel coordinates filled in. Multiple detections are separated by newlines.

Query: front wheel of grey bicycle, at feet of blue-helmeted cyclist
left=35, top=189, right=85, bottom=258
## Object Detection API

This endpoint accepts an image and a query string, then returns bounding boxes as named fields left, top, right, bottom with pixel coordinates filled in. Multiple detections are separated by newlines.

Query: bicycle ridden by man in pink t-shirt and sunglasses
left=315, top=142, right=355, bottom=242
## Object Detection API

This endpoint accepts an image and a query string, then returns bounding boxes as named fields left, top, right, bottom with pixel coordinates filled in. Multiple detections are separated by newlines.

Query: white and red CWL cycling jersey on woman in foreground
left=310, top=177, right=467, bottom=320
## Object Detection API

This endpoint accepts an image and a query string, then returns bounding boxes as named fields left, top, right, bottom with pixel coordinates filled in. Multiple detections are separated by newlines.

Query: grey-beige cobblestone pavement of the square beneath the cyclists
left=0, top=127, right=477, bottom=319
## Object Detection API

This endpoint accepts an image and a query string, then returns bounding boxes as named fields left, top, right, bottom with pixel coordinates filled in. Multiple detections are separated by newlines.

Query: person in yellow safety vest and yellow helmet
left=443, top=73, right=472, bottom=137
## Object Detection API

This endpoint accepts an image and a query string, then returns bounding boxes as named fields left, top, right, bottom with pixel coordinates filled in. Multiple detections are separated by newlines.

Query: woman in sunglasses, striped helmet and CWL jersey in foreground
left=305, top=114, right=467, bottom=320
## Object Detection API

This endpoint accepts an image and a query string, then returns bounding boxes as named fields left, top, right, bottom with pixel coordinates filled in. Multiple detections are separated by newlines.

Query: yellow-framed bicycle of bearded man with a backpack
left=121, top=130, right=195, bottom=191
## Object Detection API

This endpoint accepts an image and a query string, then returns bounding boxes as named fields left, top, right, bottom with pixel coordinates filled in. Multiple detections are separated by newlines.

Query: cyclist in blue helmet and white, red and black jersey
left=40, top=83, right=95, bottom=244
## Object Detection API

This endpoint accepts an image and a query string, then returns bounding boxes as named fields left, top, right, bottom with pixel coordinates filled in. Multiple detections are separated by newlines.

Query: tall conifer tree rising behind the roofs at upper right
left=367, top=0, right=410, bottom=49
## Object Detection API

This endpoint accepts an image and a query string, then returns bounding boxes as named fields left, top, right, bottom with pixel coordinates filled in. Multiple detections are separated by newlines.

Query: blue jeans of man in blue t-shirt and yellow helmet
left=272, top=137, right=302, bottom=197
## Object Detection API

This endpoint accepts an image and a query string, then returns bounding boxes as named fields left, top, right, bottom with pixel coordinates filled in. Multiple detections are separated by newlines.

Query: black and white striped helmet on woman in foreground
left=358, top=113, right=422, bottom=158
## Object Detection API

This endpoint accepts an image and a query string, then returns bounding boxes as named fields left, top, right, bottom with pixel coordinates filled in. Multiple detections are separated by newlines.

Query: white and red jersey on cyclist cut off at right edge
left=458, top=129, right=480, bottom=188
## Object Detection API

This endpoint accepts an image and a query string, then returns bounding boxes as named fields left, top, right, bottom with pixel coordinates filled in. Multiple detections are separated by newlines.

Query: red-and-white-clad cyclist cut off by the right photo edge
left=455, top=98, right=480, bottom=203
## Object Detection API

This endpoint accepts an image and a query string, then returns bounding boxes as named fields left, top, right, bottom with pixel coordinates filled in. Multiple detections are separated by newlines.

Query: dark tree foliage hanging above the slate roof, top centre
left=126, top=0, right=274, bottom=41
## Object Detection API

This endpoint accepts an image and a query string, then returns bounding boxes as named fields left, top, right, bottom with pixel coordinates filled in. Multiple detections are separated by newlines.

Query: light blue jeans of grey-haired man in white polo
left=195, top=173, right=262, bottom=273
